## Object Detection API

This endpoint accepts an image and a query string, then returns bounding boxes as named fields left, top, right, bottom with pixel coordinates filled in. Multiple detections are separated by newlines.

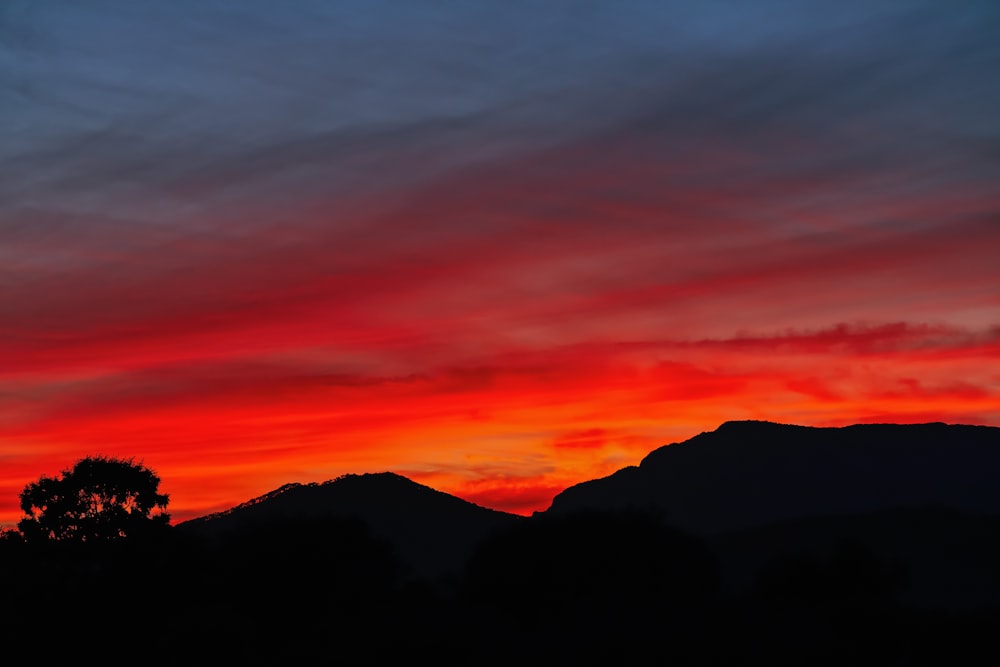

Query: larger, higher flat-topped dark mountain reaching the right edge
left=545, top=421, right=1000, bottom=534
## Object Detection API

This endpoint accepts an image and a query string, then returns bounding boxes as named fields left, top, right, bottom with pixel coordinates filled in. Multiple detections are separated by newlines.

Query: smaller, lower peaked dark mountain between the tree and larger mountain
left=176, top=472, right=524, bottom=578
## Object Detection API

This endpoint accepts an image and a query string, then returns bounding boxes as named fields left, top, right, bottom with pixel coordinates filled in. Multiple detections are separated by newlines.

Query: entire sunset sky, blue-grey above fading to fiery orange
left=0, top=0, right=1000, bottom=525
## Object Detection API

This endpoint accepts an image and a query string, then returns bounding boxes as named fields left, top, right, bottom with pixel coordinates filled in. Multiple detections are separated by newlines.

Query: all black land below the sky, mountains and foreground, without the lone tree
left=7, top=422, right=1000, bottom=666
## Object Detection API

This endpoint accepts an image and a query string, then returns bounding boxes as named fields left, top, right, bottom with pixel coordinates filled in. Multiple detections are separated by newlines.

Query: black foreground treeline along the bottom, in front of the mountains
left=0, top=511, right=1000, bottom=666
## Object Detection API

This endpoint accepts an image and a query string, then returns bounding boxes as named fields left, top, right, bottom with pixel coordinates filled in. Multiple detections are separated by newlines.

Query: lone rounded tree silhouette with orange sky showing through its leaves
left=18, top=456, right=170, bottom=542
